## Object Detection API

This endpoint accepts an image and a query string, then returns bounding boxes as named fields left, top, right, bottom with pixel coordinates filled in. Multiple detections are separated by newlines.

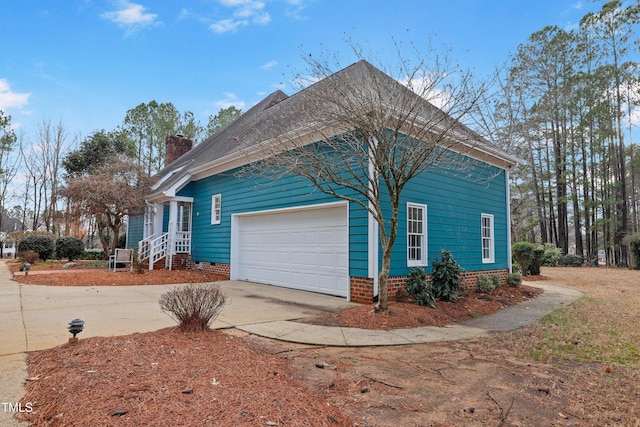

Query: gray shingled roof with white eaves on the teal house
left=149, top=60, right=517, bottom=200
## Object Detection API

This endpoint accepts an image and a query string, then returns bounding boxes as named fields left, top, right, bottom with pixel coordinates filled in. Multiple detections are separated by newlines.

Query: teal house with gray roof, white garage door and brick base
left=127, top=61, right=517, bottom=303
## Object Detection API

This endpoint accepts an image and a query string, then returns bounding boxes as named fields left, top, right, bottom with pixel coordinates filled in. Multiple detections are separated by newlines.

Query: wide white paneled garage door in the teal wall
left=232, top=204, right=349, bottom=297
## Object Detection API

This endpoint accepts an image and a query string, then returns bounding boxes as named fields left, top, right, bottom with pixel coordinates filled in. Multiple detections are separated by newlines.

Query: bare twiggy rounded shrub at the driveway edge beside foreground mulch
left=160, top=283, right=226, bottom=332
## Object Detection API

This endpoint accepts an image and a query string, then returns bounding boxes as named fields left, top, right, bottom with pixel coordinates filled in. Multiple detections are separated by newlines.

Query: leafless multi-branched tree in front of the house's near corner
left=248, top=49, right=500, bottom=312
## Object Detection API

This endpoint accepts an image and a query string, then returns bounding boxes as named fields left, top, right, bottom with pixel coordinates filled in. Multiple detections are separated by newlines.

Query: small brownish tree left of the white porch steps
left=62, top=159, right=152, bottom=258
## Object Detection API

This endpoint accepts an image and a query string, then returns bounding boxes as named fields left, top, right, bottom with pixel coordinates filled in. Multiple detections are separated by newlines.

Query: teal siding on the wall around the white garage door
left=178, top=168, right=367, bottom=276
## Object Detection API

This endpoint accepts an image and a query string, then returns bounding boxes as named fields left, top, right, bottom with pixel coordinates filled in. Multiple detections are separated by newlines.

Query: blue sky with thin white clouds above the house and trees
left=0, top=0, right=602, bottom=141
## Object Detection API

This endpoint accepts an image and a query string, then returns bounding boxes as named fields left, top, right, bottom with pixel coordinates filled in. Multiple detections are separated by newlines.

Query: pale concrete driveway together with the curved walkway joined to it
left=0, top=264, right=581, bottom=426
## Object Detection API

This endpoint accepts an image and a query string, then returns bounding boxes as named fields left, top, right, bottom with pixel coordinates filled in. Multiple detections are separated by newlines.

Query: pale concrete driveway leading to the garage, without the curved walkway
left=0, top=264, right=356, bottom=426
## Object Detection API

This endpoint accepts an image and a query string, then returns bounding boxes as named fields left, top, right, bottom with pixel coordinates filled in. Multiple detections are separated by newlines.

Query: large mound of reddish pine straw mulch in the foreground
left=17, top=328, right=355, bottom=426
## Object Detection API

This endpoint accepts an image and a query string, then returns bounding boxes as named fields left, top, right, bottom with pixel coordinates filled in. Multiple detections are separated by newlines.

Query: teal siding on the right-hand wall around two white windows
left=390, top=161, right=509, bottom=276
